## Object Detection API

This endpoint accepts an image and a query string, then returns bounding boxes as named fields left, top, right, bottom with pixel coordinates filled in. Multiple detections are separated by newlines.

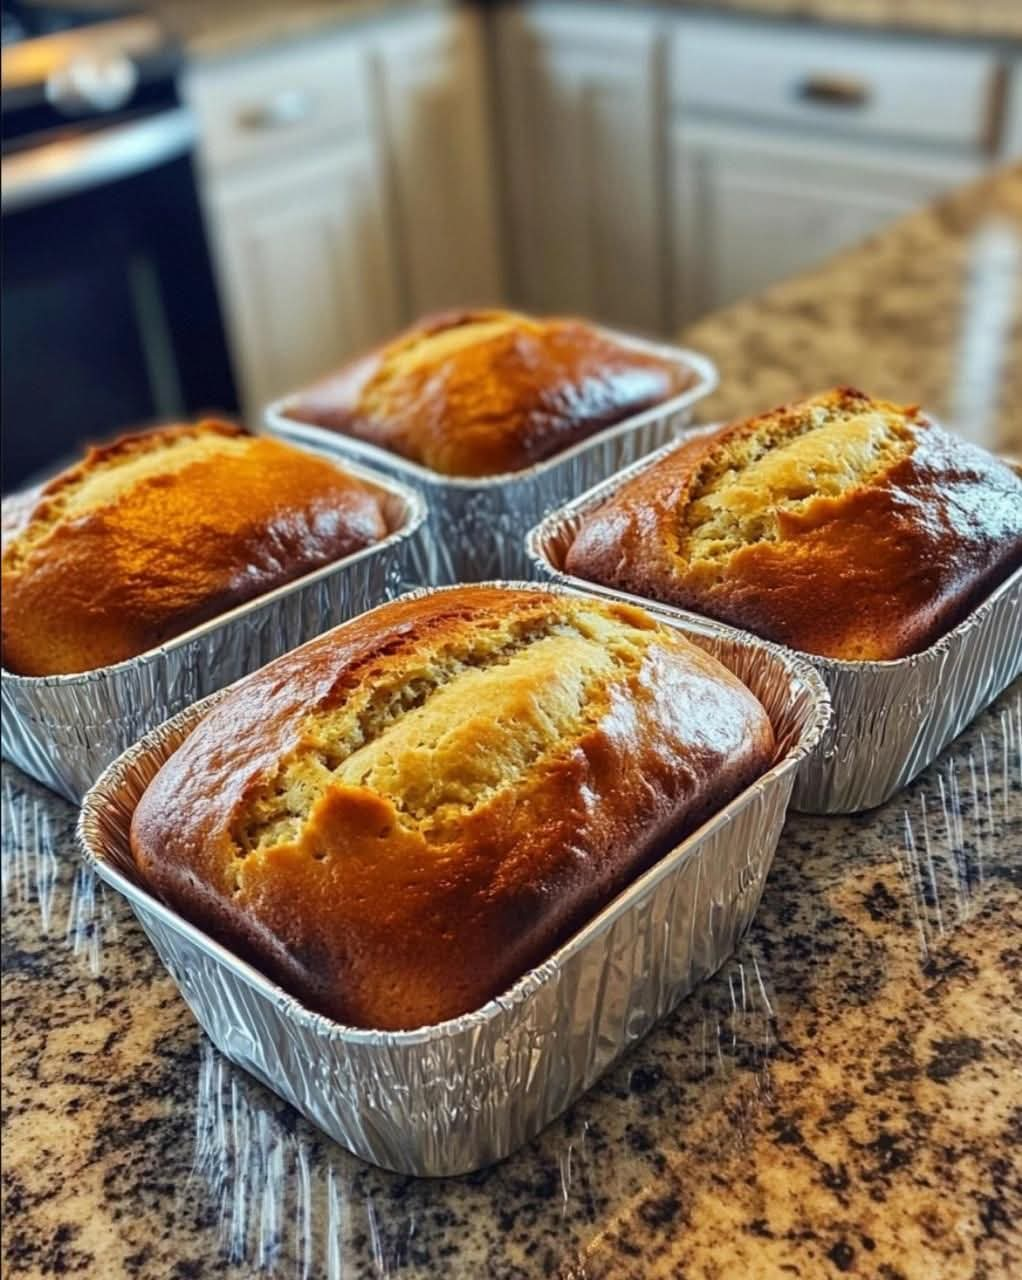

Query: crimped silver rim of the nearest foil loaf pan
left=76, top=581, right=831, bottom=1049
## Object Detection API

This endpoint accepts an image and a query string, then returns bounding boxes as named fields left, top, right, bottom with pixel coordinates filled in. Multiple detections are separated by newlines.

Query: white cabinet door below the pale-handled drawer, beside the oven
left=207, top=138, right=398, bottom=424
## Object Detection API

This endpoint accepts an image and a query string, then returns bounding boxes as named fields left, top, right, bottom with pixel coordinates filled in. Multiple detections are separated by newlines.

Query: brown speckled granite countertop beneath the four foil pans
left=3, top=172, right=1022, bottom=1280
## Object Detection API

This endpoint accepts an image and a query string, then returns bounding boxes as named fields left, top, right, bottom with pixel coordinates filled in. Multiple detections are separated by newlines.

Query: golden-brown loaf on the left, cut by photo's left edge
left=3, top=421, right=387, bottom=676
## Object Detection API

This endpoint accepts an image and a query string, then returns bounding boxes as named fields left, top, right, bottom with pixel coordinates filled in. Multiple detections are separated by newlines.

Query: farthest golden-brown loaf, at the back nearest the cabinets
left=286, top=311, right=695, bottom=476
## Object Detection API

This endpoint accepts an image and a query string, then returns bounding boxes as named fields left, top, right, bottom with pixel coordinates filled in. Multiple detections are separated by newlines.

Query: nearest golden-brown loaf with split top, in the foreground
left=131, top=586, right=774, bottom=1029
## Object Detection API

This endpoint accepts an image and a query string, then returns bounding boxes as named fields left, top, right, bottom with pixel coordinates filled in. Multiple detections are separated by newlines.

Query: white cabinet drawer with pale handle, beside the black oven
left=186, top=37, right=369, bottom=172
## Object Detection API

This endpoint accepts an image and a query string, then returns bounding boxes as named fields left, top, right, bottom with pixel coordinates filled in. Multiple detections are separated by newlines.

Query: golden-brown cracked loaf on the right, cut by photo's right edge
left=566, top=388, right=1022, bottom=660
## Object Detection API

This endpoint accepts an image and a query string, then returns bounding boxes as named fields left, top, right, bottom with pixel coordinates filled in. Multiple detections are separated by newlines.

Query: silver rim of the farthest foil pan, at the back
left=264, top=326, right=720, bottom=490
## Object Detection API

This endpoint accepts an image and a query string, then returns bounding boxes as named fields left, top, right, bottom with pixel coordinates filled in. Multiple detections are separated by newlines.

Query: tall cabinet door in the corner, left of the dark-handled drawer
left=497, top=5, right=665, bottom=332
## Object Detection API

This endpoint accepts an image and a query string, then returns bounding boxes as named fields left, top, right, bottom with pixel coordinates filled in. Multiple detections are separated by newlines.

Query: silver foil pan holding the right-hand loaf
left=526, top=440, right=1022, bottom=813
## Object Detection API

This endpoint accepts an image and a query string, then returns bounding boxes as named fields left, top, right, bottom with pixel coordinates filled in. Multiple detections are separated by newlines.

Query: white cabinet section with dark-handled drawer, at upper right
left=666, top=17, right=999, bottom=324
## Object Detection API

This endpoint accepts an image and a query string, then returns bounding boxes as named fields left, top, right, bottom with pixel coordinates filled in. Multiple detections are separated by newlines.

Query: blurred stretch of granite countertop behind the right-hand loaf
left=681, top=163, right=1022, bottom=457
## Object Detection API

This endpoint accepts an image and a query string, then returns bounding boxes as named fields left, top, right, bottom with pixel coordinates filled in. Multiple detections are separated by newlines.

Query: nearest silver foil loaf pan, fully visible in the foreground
left=78, top=584, right=829, bottom=1175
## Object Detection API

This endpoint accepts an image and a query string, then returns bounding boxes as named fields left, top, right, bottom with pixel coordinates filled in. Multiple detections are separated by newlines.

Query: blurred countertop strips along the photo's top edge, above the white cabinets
left=133, top=0, right=1022, bottom=58
